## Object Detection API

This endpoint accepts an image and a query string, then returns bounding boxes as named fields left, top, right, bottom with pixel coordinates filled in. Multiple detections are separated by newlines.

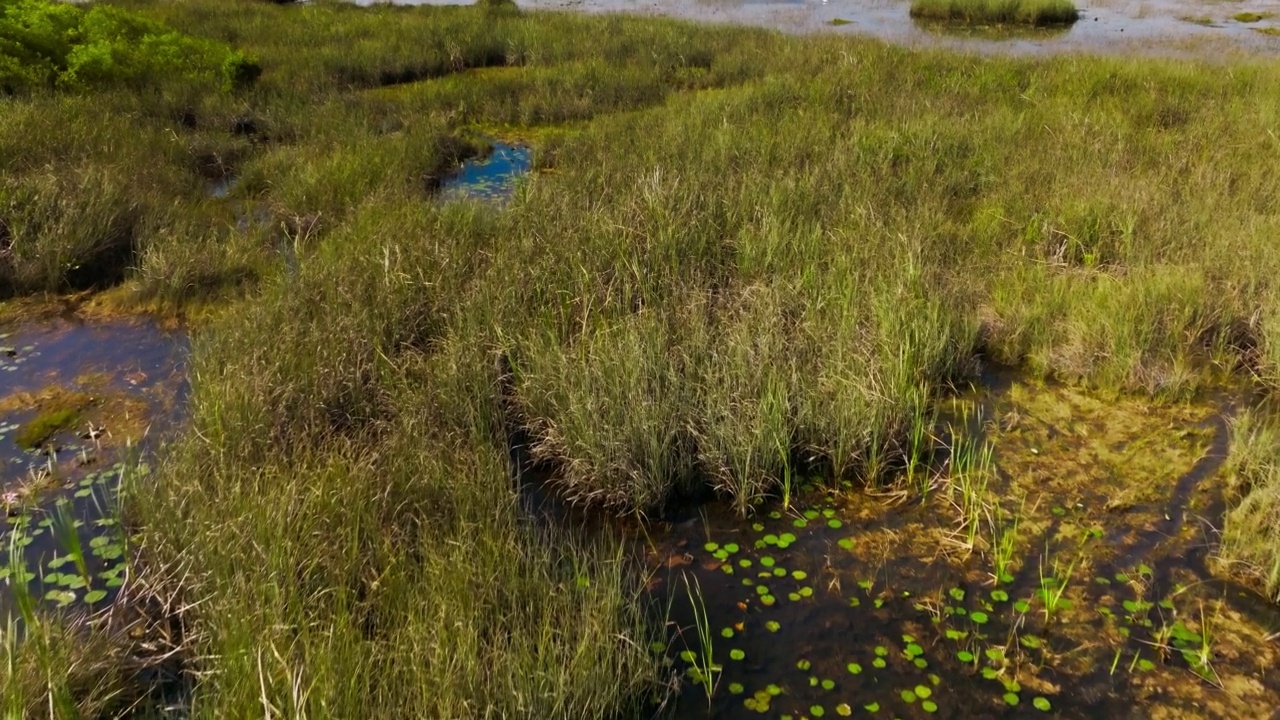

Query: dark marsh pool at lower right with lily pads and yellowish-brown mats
left=648, top=382, right=1280, bottom=720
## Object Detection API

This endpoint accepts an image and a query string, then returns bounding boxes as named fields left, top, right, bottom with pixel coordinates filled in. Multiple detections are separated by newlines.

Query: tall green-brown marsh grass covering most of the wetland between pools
left=0, top=0, right=1280, bottom=717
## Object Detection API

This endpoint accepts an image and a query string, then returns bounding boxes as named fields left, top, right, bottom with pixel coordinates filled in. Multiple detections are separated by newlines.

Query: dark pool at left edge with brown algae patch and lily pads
left=0, top=315, right=187, bottom=615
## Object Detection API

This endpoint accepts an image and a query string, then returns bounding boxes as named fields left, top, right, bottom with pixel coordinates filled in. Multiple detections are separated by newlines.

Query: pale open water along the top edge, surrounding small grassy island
left=360, top=0, right=1280, bottom=56
